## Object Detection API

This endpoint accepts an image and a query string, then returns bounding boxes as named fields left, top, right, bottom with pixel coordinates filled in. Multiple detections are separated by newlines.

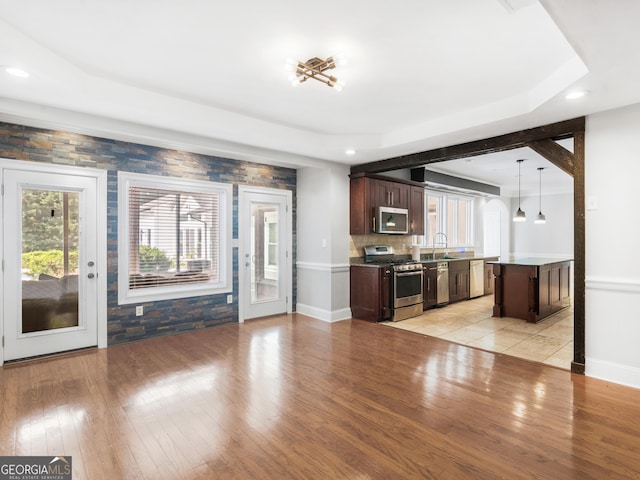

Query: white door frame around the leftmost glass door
left=0, top=158, right=107, bottom=365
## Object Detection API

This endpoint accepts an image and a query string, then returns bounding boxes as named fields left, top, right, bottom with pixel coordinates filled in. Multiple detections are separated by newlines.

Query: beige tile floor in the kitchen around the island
left=383, top=295, right=573, bottom=370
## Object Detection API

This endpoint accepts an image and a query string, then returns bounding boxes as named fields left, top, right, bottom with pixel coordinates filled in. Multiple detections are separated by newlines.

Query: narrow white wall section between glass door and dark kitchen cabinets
left=296, top=165, right=351, bottom=321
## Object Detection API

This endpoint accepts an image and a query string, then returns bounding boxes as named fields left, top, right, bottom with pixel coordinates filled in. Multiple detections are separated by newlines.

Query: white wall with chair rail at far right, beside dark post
left=585, top=105, right=640, bottom=388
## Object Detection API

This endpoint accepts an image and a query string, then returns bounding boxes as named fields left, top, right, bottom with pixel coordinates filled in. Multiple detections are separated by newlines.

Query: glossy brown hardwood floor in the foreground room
left=0, top=314, right=640, bottom=480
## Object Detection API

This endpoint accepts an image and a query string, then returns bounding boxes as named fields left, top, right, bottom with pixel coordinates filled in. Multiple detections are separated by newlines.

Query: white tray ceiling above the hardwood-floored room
left=0, top=0, right=640, bottom=193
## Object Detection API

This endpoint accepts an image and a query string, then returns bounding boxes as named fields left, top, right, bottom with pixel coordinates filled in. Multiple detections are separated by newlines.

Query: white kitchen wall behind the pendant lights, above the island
left=509, top=193, right=573, bottom=258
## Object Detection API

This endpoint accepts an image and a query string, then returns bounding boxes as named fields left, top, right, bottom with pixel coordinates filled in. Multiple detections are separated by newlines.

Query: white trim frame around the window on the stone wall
left=118, top=172, right=233, bottom=305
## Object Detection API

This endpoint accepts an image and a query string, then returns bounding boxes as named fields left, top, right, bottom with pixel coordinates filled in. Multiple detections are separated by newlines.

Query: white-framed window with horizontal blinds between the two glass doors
left=119, top=173, right=231, bottom=303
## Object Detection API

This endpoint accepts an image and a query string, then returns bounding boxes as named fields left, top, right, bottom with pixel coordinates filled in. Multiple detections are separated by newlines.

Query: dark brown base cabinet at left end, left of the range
left=350, top=265, right=391, bottom=322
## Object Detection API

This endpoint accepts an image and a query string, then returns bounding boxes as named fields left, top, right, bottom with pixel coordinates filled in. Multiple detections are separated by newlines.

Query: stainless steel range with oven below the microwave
left=364, top=245, right=424, bottom=322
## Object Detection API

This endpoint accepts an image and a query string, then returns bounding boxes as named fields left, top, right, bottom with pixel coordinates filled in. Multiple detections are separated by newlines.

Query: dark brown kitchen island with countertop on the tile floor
left=490, top=257, right=571, bottom=323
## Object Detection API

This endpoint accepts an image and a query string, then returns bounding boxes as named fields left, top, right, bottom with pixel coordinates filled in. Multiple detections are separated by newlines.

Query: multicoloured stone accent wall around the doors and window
left=0, top=122, right=296, bottom=345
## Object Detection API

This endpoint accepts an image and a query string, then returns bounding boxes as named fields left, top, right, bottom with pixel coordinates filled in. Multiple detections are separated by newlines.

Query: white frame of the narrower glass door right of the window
left=238, top=185, right=293, bottom=323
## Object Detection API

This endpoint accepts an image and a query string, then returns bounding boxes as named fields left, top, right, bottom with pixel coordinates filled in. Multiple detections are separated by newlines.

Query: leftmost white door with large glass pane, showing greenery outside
left=2, top=169, right=98, bottom=360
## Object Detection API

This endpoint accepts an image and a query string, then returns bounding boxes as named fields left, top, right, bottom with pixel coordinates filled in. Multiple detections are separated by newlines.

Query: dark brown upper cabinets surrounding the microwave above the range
left=349, top=173, right=424, bottom=235
